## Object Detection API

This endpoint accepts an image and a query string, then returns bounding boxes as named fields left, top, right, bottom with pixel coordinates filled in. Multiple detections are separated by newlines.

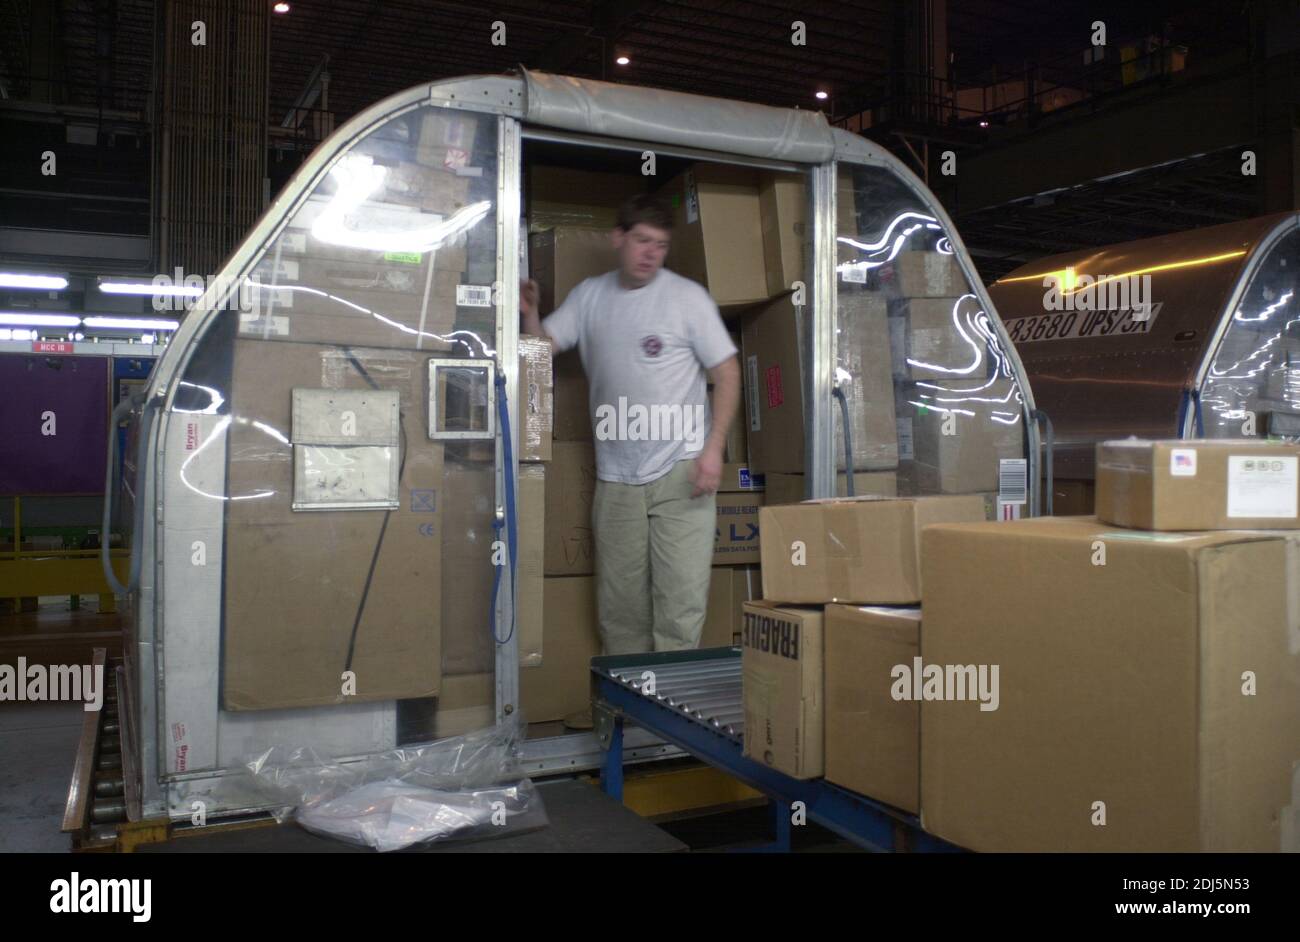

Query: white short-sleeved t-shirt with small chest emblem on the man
left=542, top=269, right=736, bottom=485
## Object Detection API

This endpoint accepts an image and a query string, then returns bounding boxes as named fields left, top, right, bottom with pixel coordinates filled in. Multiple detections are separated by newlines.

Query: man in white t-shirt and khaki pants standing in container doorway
left=520, top=195, right=744, bottom=726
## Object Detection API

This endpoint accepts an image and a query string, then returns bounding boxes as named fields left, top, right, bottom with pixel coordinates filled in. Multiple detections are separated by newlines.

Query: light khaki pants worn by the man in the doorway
left=592, top=460, right=718, bottom=654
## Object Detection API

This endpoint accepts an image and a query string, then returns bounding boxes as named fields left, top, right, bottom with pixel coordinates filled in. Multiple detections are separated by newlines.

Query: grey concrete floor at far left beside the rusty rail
left=0, top=702, right=85, bottom=854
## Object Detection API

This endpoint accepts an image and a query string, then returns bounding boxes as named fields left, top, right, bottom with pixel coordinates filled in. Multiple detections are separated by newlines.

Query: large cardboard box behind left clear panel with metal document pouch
left=223, top=340, right=445, bottom=709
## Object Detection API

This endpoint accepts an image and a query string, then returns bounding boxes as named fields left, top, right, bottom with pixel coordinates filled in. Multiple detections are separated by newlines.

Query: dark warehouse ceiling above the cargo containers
left=0, top=0, right=1257, bottom=277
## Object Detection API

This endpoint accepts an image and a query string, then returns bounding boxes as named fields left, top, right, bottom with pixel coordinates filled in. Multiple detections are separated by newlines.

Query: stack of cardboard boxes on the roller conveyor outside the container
left=744, top=440, right=1300, bottom=851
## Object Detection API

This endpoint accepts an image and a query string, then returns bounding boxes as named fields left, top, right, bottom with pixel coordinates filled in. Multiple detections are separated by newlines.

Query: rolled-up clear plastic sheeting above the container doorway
left=524, top=71, right=835, bottom=164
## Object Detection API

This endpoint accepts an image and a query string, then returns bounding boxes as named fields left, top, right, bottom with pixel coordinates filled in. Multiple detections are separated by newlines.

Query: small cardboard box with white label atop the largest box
left=1097, top=439, right=1300, bottom=530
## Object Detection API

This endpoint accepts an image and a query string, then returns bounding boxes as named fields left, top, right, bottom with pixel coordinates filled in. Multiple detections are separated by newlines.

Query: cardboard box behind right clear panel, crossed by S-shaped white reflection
left=889, top=296, right=995, bottom=379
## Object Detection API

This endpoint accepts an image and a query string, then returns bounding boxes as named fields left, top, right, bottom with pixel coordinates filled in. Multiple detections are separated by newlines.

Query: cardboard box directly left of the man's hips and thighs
left=545, top=442, right=595, bottom=576
